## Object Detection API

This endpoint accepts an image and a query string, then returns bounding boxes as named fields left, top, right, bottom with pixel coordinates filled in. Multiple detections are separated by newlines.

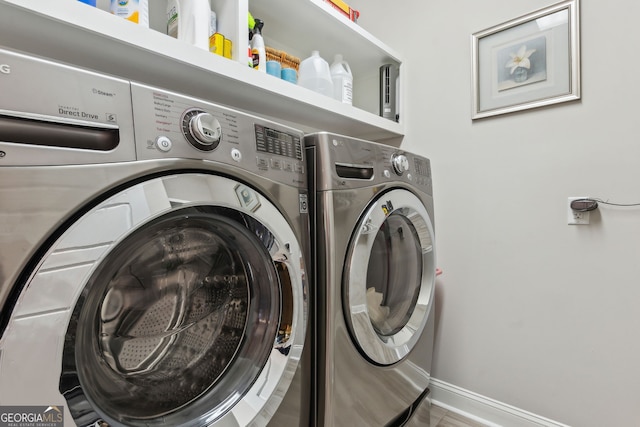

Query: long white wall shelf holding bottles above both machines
left=0, top=0, right=404, bottom=140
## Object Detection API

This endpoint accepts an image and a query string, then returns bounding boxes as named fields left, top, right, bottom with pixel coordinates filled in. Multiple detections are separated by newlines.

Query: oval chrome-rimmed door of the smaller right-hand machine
left=343, top=189, right=435, bottom=365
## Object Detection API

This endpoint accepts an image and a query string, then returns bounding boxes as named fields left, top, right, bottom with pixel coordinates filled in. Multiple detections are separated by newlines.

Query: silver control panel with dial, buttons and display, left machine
left=131, top=83, right=306, bottom=187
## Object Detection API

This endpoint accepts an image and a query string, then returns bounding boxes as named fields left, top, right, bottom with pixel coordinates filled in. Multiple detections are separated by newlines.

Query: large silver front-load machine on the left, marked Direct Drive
left=0, top=49, right=310, bottom=427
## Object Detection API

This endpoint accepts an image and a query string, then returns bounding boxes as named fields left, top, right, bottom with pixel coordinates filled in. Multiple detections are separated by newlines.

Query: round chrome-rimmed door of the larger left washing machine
left=0, top=174, right=306, bottom=426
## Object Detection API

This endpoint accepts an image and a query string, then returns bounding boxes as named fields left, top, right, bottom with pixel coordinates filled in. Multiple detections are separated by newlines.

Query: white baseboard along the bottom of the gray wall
left=429, top=378, right=569, bottom=427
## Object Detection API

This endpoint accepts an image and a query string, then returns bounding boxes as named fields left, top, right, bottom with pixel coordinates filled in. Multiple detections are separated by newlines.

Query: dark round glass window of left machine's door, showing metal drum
left=61, top=207, right=280, bottom=425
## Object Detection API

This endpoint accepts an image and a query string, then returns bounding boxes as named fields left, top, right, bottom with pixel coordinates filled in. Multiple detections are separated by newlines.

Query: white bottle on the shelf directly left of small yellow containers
left=167, top=0, right=211, bottom=51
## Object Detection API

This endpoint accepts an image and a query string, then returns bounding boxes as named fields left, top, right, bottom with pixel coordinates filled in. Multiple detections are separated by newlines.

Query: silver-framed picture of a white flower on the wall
left=471, top=0, right=580, bottom=120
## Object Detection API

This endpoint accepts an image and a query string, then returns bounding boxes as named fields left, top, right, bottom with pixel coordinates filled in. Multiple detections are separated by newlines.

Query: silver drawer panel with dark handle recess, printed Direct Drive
left=0, top=49, right=135, bottom=166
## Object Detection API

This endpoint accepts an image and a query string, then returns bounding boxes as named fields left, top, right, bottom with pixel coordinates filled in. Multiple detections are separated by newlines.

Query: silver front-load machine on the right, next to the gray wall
left=305, top=133, right=436, bottom=427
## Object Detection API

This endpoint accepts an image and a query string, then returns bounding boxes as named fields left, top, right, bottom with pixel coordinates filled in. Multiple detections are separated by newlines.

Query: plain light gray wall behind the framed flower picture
left=347, top=0, right=640, bottom=427
